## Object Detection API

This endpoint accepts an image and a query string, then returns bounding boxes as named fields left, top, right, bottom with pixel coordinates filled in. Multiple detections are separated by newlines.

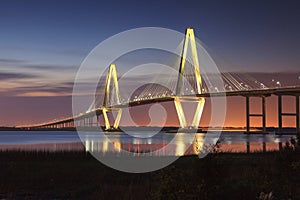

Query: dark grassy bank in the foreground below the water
left=0, top=148, right=300, bottom=200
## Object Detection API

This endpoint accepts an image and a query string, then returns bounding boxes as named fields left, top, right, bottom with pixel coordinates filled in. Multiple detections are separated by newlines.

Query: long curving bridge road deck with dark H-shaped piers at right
left=18, top=86, right=300, bottom=132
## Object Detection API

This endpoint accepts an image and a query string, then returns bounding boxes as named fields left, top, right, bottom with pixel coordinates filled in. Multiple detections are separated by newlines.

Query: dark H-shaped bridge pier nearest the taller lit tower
left=246, top=96, right=267, bottom=134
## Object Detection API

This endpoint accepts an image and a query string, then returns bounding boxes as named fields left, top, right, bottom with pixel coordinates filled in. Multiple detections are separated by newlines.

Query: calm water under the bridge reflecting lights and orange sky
left=0, top=131, right=293, bottom=155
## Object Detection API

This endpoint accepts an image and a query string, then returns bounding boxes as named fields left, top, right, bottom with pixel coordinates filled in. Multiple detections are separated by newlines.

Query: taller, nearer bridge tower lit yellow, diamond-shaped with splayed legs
left=174, top=28, right=205, bottom=128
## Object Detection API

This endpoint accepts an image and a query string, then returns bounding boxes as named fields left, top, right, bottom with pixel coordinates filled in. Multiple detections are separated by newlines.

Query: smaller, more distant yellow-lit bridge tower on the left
left=102, top=64, right=122, bottom=130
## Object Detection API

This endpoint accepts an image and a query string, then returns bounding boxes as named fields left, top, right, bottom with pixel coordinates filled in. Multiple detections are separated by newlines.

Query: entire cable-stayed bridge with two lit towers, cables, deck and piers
left=20, top=28, right=300, bottom=133
